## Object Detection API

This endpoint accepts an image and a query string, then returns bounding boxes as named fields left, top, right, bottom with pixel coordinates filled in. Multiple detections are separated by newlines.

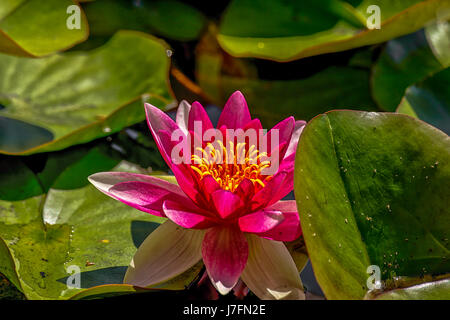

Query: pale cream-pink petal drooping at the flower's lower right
left=241, top=234, right=305, bottom=300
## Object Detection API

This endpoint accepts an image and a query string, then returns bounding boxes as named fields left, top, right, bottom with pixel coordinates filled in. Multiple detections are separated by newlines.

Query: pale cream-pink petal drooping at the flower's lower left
left=123, top=221, right=205, bottom=287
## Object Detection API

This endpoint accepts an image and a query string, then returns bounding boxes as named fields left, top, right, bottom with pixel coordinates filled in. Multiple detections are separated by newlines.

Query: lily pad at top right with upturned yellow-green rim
left=218, top=0, right=450, bottom=61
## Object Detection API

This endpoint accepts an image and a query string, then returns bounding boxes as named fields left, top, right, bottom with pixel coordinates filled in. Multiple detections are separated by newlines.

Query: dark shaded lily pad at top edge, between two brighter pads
left=85, top=0, right=206, bottom=41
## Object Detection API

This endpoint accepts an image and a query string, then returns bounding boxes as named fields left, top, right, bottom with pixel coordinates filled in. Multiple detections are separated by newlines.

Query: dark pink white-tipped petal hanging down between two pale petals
left=202, top=227, right=248, bottom=294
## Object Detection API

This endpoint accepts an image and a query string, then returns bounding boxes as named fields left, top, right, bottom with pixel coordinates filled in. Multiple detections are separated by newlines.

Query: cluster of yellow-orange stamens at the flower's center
left=191, top=140, right=272, bottom=192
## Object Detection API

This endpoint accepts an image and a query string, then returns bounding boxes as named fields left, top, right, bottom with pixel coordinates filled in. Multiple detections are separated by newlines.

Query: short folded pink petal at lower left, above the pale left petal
left=163, top=200, right=214, bottom=229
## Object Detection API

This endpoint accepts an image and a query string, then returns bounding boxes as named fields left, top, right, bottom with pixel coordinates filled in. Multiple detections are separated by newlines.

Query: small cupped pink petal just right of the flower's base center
left=238, top=210, right=284, bottom=233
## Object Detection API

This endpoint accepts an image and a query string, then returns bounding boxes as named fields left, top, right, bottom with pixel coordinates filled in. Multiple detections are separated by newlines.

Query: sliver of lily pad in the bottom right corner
left=375, top=279, right=450, bottom=300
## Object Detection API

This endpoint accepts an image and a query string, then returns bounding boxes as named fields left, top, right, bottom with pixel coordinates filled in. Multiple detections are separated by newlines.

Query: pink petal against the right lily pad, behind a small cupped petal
left=257, top=200, right=302, bottom=241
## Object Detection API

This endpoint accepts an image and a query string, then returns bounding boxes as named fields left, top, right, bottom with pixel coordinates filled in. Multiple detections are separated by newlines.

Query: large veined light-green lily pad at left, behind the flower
left=0, top=31, right=172, bottom=155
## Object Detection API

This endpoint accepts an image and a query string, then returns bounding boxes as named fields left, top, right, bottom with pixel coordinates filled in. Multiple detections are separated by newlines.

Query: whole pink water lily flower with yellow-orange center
left=89, top=91, right=305, bottom=299
